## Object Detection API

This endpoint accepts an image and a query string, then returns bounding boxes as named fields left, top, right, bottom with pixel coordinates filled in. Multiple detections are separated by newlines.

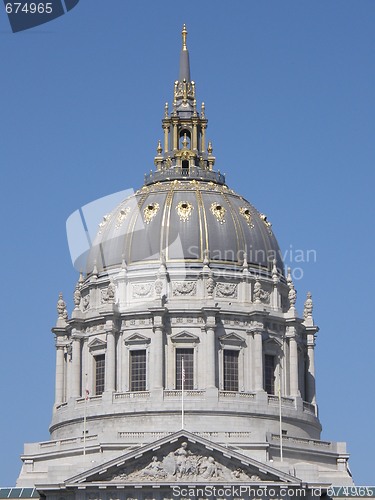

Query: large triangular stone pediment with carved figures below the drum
left=65, top=430, right=298, bottom=488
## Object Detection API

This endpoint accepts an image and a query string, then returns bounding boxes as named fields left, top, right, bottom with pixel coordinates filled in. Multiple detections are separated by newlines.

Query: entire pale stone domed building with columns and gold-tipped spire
left=17, top=26, right=352, bottom=500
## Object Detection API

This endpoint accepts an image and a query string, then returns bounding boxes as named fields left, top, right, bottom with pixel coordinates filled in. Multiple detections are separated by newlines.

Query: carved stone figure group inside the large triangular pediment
left=111, top=442, right=260, bottom=483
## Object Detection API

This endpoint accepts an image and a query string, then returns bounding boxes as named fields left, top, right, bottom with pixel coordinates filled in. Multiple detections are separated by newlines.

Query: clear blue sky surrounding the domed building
left=0, top=0, right=375, bottom=486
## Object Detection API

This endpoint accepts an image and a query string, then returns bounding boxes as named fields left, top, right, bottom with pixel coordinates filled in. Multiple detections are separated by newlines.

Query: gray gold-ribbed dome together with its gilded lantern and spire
left=86, top=25, right=284, bottom=280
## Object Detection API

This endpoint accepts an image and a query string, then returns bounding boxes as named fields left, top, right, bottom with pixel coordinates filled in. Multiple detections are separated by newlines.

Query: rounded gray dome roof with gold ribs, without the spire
left=86, top=179, right=284, bottom=274
